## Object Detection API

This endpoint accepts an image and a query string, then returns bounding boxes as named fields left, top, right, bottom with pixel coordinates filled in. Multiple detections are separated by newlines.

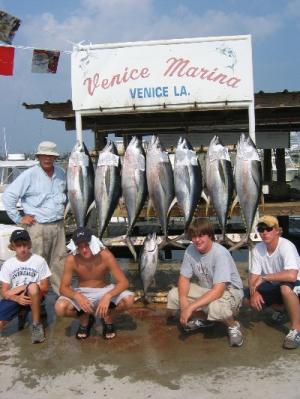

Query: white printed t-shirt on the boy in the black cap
left=0, top=254, right=51, bottom=288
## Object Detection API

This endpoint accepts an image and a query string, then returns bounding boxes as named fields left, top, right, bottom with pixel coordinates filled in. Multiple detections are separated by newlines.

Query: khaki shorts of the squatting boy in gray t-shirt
left=167, top=283, right=242, bottom=321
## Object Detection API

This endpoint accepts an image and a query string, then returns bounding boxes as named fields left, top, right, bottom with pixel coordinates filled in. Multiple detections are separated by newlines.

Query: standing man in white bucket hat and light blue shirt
left=2, top=141, right=66, bottom=294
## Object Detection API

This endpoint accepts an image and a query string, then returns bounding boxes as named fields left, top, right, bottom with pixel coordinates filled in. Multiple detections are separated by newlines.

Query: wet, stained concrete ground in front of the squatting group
left=0, top=262, right=300, bottom=399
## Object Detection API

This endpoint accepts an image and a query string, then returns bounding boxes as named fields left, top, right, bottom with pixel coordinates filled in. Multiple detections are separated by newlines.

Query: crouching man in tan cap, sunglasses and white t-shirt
left=245, top=215, right=300, bottom=349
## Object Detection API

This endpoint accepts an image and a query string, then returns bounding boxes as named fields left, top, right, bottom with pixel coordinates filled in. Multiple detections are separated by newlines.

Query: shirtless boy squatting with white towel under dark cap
left=55, top=227, right=134, bottom=339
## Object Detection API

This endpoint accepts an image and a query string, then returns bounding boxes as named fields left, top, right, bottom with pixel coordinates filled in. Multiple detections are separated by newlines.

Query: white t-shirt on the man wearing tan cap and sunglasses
left=249, top=237, right=300, bottom=280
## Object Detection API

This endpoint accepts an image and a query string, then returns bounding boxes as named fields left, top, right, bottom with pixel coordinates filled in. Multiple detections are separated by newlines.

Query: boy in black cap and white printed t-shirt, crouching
left=0, top=229, right=51, bottom=344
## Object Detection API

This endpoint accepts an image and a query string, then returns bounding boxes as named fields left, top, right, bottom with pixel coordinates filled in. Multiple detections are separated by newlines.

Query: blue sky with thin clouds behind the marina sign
left=0, top=0, right=300, bottom=153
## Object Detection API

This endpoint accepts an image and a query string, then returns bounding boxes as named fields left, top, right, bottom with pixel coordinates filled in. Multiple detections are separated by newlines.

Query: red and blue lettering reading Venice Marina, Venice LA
left=83, top=57, right=241, bottom=98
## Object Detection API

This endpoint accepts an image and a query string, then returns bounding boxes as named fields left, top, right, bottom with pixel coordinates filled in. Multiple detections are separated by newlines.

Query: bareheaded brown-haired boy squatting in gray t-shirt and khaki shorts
left=167, top=219, right=243, bottom=346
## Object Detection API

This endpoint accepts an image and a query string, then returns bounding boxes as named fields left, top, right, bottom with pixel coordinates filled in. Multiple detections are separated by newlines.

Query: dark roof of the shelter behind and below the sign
left=23, top=90, right=300, bottom=135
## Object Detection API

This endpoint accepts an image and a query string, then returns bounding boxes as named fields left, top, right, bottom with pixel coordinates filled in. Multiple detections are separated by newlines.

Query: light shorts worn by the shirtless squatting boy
left=57, top=284, right=134, bottom=312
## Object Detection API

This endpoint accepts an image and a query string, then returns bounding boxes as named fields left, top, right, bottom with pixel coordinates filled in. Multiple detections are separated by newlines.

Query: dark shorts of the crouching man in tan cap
left=244, top=280, right=300, bottom=307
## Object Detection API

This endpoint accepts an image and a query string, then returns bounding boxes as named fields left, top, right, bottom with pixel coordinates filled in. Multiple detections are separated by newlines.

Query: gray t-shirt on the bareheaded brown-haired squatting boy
left=180, top=242, right=243, bottom=296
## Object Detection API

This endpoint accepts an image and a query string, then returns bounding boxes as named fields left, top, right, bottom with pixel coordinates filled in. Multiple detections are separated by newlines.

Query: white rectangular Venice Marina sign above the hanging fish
left=72, top=36, right=253, bottom=112
